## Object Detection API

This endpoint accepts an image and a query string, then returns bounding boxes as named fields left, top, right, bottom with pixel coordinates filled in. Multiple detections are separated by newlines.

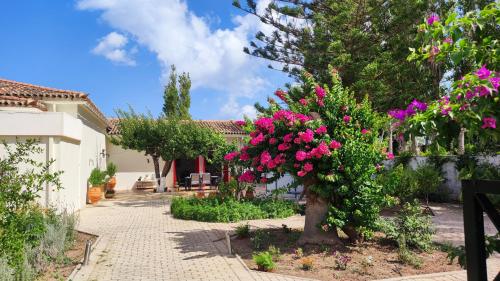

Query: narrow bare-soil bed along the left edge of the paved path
left=37, top=231, right=97, bottom=281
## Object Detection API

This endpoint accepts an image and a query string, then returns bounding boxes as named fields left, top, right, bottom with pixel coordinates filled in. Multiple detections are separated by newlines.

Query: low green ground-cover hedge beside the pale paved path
left=170, top=197, right=297, bottom=222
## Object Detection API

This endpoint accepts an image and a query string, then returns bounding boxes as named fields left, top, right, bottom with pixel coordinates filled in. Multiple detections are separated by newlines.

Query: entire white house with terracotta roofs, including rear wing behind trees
left=0, top=79, right=249, bottom=210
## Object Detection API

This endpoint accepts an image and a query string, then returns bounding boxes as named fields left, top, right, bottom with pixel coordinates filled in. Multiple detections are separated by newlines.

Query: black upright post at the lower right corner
left=462, top=181, right=488, bottom=281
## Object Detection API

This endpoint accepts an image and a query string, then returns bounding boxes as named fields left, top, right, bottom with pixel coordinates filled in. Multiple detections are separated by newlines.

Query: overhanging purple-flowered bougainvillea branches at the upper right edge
left=398, top=2, right=500, bottom=142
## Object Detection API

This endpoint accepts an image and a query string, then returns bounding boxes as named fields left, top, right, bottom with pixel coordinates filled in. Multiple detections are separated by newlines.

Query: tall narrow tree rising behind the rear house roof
left=163, top=65, right=191, bottom=120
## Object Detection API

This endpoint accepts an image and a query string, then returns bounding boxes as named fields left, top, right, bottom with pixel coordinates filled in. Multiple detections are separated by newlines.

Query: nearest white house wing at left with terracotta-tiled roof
left=0, top=79, right=108, bottom=210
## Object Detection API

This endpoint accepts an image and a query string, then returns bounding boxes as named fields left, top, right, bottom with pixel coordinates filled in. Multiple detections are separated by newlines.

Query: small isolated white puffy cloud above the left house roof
left=92, top=32, right=135, bottom=65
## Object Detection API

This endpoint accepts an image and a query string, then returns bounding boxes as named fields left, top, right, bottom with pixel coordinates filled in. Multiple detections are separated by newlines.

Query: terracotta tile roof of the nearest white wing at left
left=0, top=78, right=107, bottom=122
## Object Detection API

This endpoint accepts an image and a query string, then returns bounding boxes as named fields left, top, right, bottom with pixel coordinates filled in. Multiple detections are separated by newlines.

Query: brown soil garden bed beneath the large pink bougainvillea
left=231, top=229, right=460, bottom=280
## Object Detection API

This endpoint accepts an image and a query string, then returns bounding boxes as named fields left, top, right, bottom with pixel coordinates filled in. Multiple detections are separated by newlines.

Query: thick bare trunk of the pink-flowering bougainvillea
left=297, top=187, right=342, bottom=245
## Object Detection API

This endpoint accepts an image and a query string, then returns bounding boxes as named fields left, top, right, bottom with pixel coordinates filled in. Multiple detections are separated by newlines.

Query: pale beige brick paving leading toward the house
left=72, top=193, right=500, bottom=281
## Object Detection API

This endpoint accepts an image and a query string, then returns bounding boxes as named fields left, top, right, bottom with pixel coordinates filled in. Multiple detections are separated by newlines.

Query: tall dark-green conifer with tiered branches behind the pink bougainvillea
left=233, top=0, right=449, bottom=110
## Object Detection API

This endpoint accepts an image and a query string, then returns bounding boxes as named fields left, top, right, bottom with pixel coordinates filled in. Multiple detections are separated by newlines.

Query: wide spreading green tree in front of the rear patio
left=111, top=108, right=228, bottom=182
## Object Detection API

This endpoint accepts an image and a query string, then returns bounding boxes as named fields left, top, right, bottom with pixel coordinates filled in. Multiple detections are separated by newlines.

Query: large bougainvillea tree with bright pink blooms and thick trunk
left=225, top=70, right=386, bottom=244
